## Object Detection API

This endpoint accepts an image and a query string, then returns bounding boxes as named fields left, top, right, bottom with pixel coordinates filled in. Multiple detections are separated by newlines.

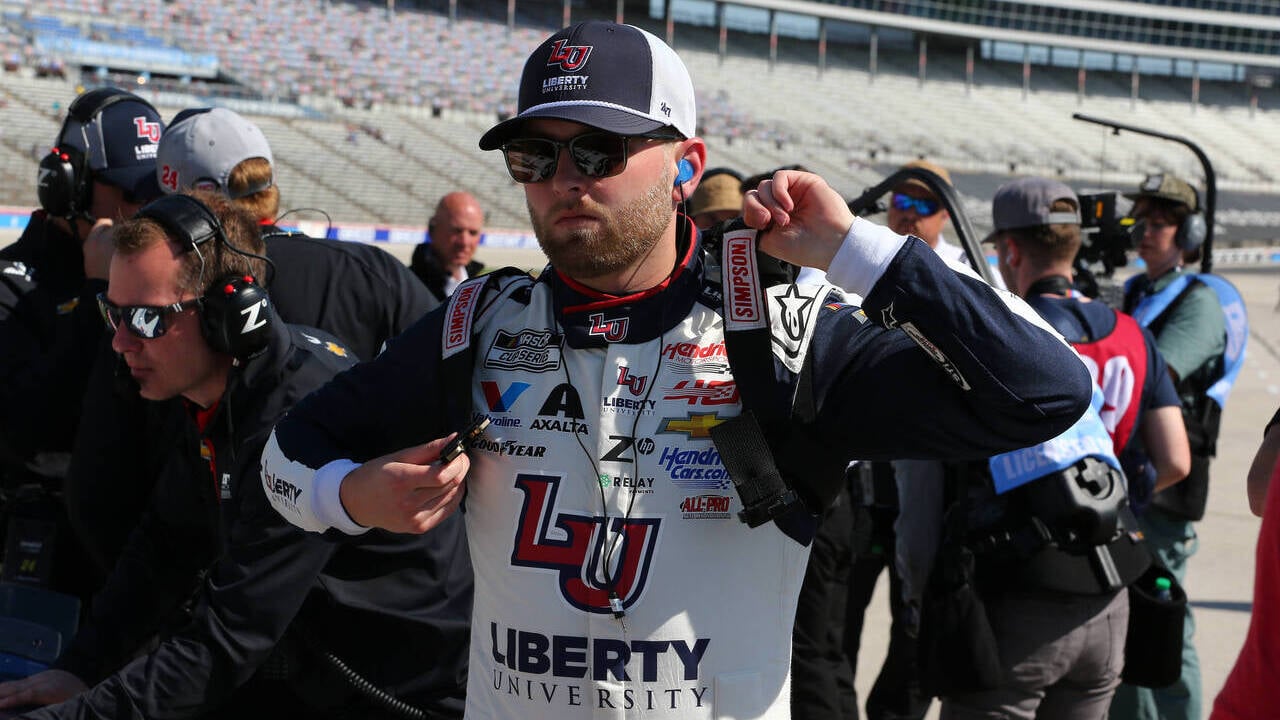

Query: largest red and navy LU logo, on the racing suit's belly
left=511, top=473, right=662, bottom=614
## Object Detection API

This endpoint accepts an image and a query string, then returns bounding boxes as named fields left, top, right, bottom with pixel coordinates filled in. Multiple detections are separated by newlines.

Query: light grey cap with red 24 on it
left=155, top=108, right=274, bottom=200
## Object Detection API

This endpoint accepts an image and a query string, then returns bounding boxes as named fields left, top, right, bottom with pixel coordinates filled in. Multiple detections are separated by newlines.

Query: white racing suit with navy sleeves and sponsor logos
left=262, top=219, right=1092, bottom=720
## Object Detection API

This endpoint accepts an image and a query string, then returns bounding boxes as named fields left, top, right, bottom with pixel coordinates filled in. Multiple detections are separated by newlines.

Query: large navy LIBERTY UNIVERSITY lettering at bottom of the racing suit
left=486, top=623, right=712, bottom=716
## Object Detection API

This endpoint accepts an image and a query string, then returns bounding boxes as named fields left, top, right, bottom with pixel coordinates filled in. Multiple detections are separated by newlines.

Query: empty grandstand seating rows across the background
left=0, top=0, right=1280, bottom=228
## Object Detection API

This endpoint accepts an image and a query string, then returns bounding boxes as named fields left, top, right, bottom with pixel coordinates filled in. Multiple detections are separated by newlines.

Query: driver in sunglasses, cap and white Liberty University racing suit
left=262, top=22, right=1089, bottom=720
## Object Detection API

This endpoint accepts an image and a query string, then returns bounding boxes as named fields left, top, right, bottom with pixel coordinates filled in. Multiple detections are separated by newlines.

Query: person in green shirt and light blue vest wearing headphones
left=1111, top=173, right=1248, bottom=720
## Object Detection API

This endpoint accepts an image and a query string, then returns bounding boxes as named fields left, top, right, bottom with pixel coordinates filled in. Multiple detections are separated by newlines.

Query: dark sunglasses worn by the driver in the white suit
left=502, top=132, right=681, bottom=184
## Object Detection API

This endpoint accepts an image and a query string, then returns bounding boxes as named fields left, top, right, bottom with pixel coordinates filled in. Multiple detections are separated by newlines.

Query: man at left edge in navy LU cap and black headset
left=0, top=87, right=164, bottom=594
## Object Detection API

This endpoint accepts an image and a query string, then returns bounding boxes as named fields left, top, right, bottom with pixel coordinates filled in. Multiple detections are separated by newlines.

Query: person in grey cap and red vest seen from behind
left=922, top=178, right=1167, bottom=720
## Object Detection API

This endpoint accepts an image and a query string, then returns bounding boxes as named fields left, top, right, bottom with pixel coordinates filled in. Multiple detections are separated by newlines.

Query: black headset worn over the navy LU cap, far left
left=36, top=87, right=159, bottom=222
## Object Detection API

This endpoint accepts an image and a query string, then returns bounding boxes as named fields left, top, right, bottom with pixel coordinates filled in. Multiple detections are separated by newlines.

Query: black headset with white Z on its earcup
left=134, top=193, right=275, bottom=360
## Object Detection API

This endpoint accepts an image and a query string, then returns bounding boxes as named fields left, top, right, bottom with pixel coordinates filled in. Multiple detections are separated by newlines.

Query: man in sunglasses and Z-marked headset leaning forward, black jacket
left=0, top=191, right=471, bottom=719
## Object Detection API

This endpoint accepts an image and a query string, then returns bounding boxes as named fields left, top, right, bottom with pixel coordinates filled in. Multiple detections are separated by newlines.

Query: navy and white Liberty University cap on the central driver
left=480, top=20, right=698, bottom=150
